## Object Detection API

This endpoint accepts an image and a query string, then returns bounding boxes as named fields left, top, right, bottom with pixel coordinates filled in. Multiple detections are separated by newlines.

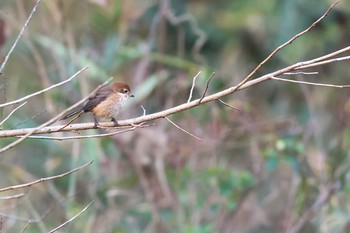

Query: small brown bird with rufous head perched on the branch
left=61, top=81, right=134, bottom=127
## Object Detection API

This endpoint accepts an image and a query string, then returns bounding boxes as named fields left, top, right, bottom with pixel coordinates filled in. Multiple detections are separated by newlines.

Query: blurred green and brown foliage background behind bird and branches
left=0, top=0, right=350, bottom=233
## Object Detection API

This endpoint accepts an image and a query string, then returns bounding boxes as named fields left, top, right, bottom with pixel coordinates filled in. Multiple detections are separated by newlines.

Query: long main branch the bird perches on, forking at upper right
left=0, top=4, right=350, bottom=140
